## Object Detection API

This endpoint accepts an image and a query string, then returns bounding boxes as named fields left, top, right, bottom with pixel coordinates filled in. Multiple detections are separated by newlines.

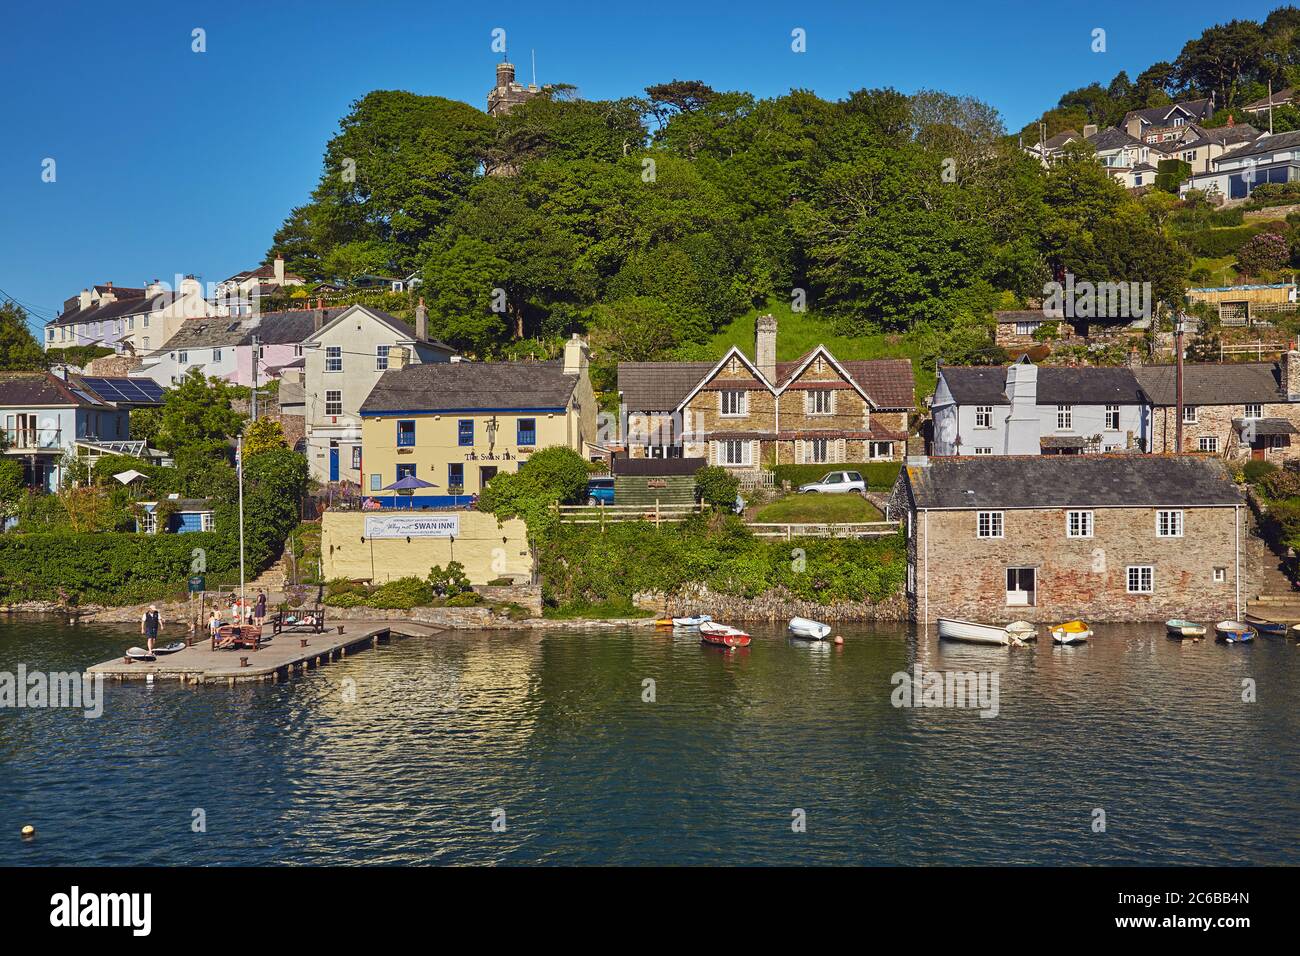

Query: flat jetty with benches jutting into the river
left=87, top=620, right=443, bottom=687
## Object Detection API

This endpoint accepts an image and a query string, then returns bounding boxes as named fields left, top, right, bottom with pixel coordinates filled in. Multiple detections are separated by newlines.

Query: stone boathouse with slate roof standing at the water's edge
left=892, top=455, right=1251, bottom=626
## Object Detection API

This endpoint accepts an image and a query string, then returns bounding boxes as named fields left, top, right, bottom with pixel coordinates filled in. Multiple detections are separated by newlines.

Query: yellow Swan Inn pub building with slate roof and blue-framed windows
left=361, top=336, right=597, bottom=507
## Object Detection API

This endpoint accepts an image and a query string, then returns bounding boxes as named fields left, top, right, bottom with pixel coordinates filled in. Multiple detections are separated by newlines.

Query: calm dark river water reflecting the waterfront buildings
left=0, top=617, right=1300, bottom=865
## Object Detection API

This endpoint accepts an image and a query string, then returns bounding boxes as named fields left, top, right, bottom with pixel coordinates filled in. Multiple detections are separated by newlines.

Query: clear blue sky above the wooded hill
left=0, top=0, right=1282, bottom=335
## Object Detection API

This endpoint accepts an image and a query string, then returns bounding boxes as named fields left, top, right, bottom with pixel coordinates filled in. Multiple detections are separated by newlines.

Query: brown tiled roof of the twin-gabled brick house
left=619, top=350, right=917, bottom=411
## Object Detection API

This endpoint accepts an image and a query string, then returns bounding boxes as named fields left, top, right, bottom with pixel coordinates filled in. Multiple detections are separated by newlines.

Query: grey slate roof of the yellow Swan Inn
left=361, top=360, right=579, bottom=415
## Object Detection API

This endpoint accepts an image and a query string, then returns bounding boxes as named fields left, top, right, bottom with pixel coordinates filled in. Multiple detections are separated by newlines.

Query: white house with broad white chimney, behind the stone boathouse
left=931, top=359, right=1151, bottom=455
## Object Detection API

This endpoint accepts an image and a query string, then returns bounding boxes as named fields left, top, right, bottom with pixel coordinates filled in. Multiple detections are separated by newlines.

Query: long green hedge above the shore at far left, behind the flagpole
left=0, top=532, right=239, bottom=604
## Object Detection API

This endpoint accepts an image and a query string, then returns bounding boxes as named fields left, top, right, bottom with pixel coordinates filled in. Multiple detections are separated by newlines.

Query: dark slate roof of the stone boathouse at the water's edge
left=904, top=455, right=1244, bottom=510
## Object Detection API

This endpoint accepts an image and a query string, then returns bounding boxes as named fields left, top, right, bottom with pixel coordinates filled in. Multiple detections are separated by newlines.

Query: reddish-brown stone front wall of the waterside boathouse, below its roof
left=909, top=507, right=1252, bottom=623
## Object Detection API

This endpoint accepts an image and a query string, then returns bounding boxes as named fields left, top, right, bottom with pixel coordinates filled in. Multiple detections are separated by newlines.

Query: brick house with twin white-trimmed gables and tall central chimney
left=619, top=316, right=915, bottom=471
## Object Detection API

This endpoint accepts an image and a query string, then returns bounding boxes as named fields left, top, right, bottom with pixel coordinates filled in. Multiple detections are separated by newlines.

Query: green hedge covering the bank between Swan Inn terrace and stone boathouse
left=538, top=516, right=907, bottom=609
